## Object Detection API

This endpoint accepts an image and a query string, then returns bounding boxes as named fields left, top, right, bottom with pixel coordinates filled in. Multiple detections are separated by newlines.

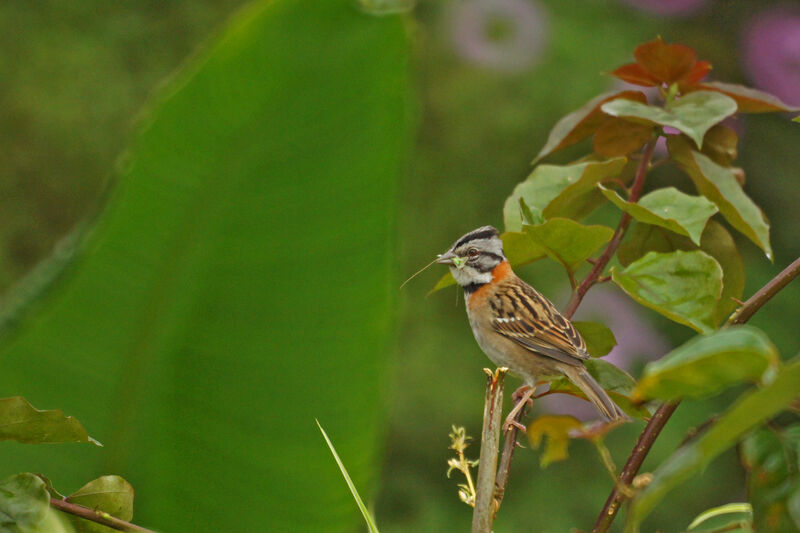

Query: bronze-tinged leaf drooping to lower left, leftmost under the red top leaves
left=533, top=91, right=647, bottom=164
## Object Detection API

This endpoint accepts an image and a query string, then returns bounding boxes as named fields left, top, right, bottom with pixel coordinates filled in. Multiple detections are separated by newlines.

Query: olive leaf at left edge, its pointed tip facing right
left=0, top=396, right=102, bottom=446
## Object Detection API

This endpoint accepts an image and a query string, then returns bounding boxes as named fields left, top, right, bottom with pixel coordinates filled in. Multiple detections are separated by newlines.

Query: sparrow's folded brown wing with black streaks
left=490, top=279, right=589, bottom=365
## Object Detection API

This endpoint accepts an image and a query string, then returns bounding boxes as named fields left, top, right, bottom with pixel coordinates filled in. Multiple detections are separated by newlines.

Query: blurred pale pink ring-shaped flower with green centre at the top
left=450, top=0, right=549, bottom=71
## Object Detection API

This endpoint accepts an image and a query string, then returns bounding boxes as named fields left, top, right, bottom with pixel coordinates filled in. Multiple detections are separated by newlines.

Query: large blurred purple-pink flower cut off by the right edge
left=742, top=5, right=800, bottom=105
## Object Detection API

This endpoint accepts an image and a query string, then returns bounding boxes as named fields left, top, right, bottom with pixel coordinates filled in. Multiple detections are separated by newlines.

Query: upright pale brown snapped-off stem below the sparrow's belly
left=472, top=368, right=508, bottom=533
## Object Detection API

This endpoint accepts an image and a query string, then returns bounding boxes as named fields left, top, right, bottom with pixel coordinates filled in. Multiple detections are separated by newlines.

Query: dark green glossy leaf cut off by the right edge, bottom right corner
left=739, top=424, right=800, bottom=531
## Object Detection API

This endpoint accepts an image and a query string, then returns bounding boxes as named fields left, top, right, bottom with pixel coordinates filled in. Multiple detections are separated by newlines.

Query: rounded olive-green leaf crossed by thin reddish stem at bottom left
left=67, top=476, right=133, bottom=533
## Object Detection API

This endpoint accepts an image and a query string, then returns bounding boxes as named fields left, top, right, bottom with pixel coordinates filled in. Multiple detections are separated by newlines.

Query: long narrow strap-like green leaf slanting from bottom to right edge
left=625, top=359, right=800, bottom=533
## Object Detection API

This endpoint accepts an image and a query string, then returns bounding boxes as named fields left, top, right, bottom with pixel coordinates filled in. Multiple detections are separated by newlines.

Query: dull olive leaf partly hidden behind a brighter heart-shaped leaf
left=617, top=220, right=744, bottom=324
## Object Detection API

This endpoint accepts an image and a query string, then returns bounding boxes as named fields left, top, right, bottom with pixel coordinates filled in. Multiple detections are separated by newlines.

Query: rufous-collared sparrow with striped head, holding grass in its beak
left=436, top=226, right=629, bottom=428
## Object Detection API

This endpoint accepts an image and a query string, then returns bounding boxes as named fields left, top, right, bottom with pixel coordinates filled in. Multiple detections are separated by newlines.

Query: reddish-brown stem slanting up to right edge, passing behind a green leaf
left=592, top=258, right=800, bottom=533
